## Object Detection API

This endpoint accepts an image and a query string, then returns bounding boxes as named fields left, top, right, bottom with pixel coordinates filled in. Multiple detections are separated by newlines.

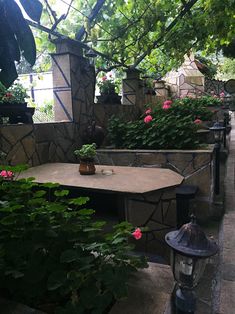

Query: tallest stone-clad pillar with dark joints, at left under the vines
left=52, top=39, right=95, bottom=127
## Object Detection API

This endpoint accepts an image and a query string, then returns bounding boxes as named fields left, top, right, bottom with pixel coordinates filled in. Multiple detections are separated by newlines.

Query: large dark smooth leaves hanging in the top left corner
left=0, top=0, right=42, bottom=87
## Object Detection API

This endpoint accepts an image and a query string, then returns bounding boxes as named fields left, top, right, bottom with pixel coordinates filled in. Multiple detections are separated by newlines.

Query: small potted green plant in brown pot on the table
left=74, top=143, right=96, bottom=175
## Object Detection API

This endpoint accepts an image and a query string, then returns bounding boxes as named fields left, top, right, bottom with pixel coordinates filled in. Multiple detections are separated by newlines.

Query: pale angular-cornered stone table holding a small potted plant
left=19, top=163, right=184, bottom=221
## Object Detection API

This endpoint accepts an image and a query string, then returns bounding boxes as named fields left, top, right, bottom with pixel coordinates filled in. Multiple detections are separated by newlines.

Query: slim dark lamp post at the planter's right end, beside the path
left=210, top=122, right=225, bottom=195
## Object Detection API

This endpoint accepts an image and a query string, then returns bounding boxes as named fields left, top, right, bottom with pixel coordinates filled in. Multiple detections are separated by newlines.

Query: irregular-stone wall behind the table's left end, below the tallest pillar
left=0, top=122, right=81, bottom=166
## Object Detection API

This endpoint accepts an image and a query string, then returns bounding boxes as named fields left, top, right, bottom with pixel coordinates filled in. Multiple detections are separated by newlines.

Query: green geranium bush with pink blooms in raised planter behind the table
left=108, top=97, right=214, bottom=149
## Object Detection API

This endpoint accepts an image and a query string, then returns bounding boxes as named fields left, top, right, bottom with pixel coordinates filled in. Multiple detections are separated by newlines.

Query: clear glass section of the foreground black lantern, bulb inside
left=172, top=252, right=206, bottom=288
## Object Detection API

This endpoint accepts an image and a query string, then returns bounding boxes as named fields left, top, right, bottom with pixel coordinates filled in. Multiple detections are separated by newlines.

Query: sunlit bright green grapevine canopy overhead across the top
left=33, top=0, right=235, bottom=73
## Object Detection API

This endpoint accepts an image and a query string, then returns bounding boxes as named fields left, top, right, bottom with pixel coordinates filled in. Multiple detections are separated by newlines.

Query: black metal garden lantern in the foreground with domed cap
left=165, top=215, right=218, bottom=314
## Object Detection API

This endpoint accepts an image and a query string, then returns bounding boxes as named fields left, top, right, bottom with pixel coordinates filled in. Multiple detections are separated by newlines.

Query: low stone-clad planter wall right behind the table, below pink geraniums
left=97, top=146, right=214, bottom=220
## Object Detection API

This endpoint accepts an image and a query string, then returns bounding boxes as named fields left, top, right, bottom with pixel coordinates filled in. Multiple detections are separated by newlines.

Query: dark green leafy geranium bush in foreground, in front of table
left=0, top=179, right=146, bottom=314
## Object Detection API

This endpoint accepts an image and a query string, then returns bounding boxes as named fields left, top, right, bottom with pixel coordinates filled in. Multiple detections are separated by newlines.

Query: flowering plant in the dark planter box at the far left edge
left=0, top=82, right=29, bottom=104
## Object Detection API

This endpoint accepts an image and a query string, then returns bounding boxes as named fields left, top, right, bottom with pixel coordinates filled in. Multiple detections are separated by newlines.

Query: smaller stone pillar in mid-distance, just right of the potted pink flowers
left=122, top=69, right=144, bottom=108
